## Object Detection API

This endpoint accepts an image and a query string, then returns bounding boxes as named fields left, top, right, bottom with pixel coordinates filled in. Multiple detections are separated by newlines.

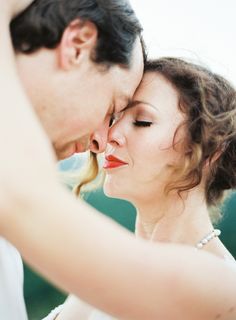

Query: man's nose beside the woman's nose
left=89, top=124, right=108, bottom=153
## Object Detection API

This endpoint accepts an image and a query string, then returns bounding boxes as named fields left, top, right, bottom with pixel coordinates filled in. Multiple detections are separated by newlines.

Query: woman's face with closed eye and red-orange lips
left=104, top=72, right=184, bottom=202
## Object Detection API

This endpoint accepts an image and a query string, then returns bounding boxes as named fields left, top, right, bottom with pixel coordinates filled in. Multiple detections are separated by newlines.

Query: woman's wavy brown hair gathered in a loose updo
left=145, top=58, right=236, bottom=206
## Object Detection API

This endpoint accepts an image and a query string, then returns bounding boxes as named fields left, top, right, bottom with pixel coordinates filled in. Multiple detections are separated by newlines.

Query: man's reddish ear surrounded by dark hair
left=58, top=19, right=98, bottom=70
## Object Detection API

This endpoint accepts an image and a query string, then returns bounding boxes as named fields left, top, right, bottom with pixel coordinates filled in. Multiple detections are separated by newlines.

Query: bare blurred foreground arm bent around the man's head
left=0, top=0, right=236, bottom=320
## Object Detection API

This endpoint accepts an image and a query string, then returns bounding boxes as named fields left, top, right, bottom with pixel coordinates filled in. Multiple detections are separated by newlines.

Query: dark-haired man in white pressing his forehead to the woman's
left=0, top=0, right=144, bottom=320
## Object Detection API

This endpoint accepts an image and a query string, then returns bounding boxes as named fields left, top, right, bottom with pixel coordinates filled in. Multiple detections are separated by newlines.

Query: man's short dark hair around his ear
left=11, top=0, right=142, bottom=67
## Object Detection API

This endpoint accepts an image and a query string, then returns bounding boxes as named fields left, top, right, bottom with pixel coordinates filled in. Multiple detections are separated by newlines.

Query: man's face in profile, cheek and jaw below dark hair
left=17, top=37, right=143, bottom=159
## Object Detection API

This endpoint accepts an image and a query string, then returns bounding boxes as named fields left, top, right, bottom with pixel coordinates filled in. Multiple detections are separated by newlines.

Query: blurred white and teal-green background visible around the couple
left=24, top=0, right=236, bottom=320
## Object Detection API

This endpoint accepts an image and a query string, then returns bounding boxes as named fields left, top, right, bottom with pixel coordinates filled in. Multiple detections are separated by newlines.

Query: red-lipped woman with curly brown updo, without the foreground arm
left=48, top=58, right=236, bottom=320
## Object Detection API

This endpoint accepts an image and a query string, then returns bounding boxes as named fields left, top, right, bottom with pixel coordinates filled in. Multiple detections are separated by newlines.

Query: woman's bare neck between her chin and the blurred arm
left=136, top=192, right=213, bottom=246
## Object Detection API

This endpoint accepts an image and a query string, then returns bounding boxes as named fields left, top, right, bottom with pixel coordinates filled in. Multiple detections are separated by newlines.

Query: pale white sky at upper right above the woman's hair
left=130, top=0, right=236, bottom=86
